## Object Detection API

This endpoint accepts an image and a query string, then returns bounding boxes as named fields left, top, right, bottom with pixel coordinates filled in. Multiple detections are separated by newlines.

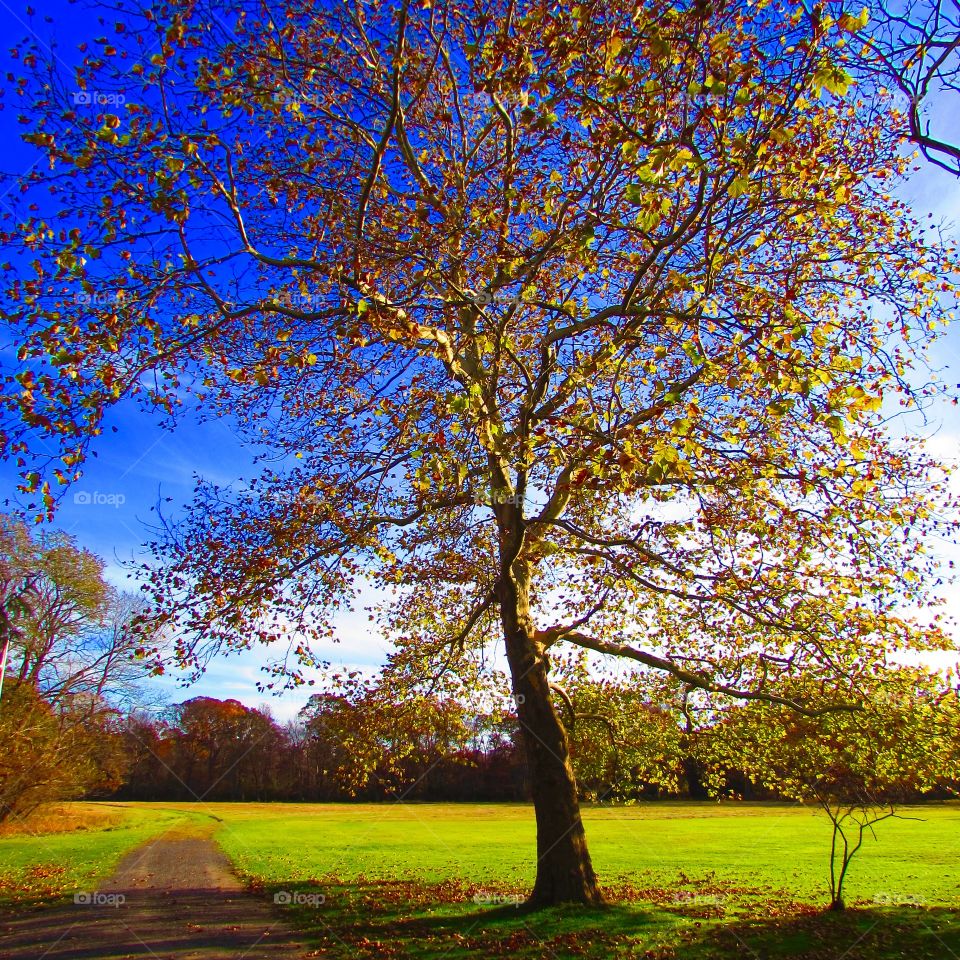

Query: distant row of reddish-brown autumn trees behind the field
left=108, top=695, right=752, bottom=802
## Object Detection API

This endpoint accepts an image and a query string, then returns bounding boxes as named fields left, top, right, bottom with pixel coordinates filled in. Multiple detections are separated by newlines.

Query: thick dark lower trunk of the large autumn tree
left=499, top=548, right=603, bottom=907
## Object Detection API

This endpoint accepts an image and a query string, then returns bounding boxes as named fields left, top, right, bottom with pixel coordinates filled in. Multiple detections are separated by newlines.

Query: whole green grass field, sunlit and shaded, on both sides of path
left=0, top=803, right=960, bottom=960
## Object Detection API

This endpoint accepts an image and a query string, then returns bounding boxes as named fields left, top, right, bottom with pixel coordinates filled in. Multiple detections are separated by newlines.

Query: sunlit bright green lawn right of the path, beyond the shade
left=204, top=803, right=960, bottom=905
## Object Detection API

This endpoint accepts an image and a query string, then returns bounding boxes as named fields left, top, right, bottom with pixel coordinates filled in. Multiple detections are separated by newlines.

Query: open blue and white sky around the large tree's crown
left=0, top=0, right=960, bottom=719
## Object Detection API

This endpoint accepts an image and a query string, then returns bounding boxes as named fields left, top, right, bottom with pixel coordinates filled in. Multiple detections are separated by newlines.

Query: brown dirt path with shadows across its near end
left=0, top=832, right=318, bottom=960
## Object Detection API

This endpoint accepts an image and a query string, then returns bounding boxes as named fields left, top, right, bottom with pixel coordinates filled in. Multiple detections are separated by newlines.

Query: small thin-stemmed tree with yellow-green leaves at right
left=695, top=666, right=960, bottom=910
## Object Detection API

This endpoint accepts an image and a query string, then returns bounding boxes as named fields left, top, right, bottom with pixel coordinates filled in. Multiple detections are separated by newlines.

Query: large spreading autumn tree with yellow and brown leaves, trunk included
left=5, top=0, right=953, bottom=904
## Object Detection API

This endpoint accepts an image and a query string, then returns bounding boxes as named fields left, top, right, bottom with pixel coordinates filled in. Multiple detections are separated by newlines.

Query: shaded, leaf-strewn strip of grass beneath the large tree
left=262, top=877, right=960, bottom=960
